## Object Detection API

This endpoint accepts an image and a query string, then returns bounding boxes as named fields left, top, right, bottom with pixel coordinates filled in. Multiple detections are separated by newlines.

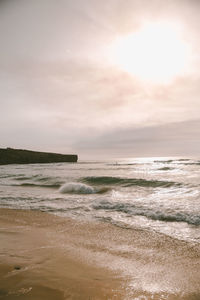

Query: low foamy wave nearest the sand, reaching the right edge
left=93, top=201, right=200, bottom=226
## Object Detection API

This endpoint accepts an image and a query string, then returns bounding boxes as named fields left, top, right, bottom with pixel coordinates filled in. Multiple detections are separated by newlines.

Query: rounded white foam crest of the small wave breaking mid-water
left=59, top=182, right=96, bottom=194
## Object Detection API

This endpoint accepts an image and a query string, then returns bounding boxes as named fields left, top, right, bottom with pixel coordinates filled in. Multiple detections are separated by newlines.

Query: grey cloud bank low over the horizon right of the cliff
left=74, top=119, right=200, bottom=158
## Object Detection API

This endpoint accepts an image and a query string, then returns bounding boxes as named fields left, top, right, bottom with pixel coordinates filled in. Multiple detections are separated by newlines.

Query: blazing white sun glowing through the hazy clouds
left=111, top=22, right=190, bottom=83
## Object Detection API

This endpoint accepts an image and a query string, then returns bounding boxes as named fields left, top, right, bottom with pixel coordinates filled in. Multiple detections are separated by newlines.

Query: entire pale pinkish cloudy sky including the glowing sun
left=0, top=0, right=200, bottom=159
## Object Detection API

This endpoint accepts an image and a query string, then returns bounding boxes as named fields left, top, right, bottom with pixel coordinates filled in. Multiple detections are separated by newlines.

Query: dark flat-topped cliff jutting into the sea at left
left=0, top=148, right=78, bottom=165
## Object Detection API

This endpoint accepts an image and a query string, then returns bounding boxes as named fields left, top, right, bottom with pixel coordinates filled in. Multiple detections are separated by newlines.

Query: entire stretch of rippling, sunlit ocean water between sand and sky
left=0, top=158, right=200, bottom=243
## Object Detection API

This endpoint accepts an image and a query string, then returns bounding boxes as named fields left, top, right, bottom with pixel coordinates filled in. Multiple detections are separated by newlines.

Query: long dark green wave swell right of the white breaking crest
left=81, top=176, right=181, bottom=188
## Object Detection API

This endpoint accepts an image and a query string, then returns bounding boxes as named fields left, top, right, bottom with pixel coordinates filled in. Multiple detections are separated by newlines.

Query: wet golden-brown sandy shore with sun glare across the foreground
left=0, top=209, right=200, bottom=300
